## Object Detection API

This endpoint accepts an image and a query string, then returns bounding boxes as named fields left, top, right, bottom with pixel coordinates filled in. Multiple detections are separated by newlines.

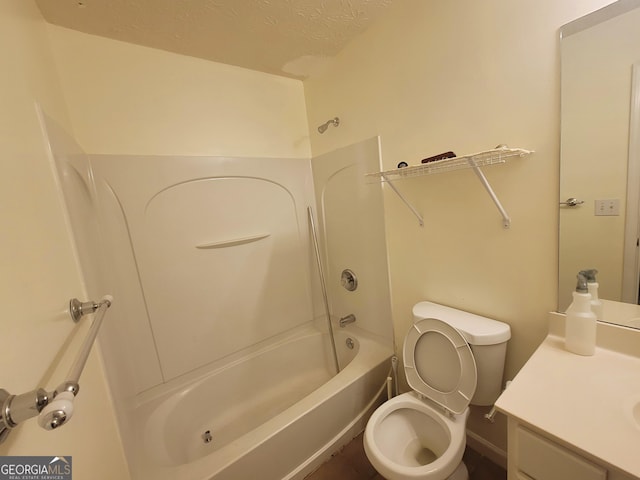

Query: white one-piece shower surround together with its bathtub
left=44, top=111, right=393, bottom=480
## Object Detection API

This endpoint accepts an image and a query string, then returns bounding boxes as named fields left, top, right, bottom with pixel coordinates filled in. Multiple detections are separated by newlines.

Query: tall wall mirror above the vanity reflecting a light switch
left=558, top=0, right=640, bottom=328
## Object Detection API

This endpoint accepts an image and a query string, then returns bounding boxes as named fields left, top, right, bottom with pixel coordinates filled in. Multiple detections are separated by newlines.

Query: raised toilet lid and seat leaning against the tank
left=403, top=318, right=478, bottom=414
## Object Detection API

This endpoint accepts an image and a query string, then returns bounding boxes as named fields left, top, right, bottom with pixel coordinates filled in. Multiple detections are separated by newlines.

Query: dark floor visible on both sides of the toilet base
left=305, top=434, right=507, bottom=480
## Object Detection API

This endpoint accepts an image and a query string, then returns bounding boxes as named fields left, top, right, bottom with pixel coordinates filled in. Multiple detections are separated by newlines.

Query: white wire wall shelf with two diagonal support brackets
left=365, top=145, right=534, bottom=228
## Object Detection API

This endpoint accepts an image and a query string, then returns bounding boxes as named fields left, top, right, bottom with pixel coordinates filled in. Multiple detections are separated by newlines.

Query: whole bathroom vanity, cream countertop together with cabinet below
left=495, top=313, right=640, bottom=480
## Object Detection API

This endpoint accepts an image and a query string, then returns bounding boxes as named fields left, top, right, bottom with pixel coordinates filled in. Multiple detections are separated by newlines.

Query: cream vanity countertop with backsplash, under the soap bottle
left=496, top=315, right=640, bottom=478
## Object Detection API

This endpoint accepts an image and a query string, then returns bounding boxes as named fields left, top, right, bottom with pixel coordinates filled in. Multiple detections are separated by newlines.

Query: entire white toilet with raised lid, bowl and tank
left=364, top=302, right=511, bottom=480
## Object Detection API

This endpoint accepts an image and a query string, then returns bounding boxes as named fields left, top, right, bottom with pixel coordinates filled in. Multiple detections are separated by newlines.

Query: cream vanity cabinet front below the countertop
left=507, top=417, right=635, bottom=480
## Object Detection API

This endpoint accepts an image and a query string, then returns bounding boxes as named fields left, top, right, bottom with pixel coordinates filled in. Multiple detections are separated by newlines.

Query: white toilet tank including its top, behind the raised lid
left=413, top=302, right=511, bottom=405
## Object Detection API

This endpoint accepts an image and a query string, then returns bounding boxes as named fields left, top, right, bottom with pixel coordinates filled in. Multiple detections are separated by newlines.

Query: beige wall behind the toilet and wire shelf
left=305, top=0, right=610, bottom=450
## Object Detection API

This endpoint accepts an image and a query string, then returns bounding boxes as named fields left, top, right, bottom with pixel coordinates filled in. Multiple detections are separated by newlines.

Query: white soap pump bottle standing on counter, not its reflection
left=565, top=272, right=597, bottom=355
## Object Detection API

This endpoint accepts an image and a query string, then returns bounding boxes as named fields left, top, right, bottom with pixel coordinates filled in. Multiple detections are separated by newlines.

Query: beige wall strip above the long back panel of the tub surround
left=49, top=25, right=310, bottom=158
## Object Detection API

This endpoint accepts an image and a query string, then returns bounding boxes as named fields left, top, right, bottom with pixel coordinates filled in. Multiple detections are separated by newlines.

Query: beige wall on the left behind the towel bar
left=0, top=0, right=129, bottom=480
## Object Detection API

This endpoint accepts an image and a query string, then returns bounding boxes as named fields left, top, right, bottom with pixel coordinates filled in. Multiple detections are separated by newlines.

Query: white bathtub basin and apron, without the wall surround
left=133, top=325, right=392, bottom=480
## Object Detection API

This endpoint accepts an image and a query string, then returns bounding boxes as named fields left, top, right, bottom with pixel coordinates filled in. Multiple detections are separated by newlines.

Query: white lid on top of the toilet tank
left=413, top=302, right=511, bottom=345
